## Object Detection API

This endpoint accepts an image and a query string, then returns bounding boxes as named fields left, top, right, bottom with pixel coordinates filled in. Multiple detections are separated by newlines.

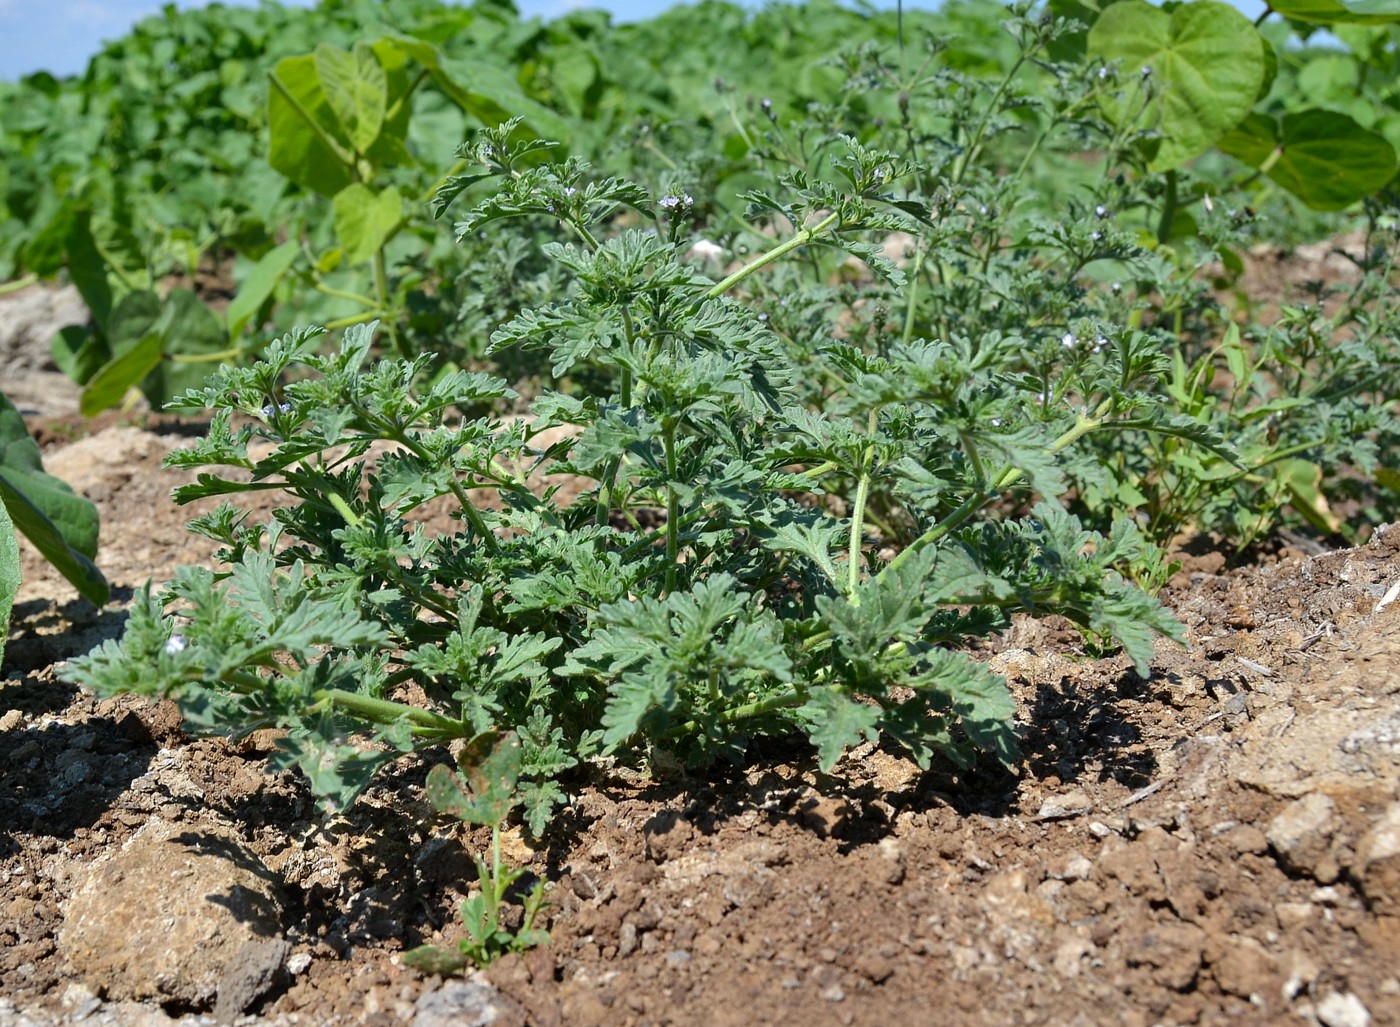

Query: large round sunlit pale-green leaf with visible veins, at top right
left=1089, top=0, right=1267, bottom=171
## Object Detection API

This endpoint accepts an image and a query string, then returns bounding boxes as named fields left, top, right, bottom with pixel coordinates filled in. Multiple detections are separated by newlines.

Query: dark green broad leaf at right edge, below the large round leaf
left=1218, top=109, right=1396, bottom=210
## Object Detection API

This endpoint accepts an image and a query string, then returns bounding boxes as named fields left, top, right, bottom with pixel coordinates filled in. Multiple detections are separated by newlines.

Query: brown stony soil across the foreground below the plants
left=0, top=275, right=1400, bottom=1027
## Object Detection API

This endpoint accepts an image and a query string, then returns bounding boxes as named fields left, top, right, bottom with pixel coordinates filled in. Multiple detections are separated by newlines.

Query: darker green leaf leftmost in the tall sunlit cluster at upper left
left=267, top=55, right=354, bottom=196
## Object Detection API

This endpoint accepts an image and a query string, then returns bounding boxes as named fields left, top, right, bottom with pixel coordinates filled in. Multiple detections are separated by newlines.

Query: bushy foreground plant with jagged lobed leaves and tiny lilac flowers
left=73, top=106, right=1204, bottom=831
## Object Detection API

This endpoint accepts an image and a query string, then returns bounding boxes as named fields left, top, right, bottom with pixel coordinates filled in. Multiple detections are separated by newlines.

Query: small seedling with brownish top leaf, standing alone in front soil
left=403, top=732, right=549, bottom=974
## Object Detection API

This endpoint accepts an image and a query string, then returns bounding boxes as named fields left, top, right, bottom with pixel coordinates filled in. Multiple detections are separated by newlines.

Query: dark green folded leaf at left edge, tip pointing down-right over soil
left=0, top=393, right=108, bottom=606
